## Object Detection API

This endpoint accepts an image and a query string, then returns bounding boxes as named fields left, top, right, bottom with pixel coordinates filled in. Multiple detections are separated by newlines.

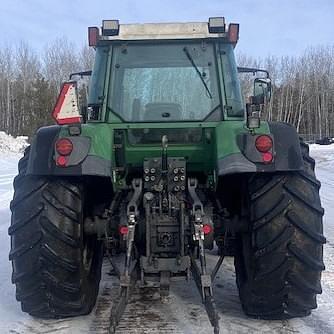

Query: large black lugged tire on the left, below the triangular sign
left=8, top=149, right=103, bottom=318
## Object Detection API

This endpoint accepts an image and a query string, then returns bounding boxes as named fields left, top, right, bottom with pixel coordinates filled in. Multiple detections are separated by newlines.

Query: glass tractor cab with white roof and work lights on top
left=88, top=18, right=244, bottom=123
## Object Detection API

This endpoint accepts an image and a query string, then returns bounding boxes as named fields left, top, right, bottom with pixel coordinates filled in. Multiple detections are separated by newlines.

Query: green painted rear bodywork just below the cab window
left=60, top=120, right=270, bottom=173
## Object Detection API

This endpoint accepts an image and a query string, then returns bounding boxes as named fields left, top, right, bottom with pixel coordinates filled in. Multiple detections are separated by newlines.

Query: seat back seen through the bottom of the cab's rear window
left=144, top=102, right=182, bottom=122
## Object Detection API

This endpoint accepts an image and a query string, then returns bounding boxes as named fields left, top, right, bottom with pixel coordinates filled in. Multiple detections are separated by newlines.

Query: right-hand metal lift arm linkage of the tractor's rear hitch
left=188, top=179, right=223, bottom=334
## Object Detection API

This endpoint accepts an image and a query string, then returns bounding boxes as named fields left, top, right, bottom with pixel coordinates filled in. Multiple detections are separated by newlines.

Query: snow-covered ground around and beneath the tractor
left=0, top=140, right=334, bottom=334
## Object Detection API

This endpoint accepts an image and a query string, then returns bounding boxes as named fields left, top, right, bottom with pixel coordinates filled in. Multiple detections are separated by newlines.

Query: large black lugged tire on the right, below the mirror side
left=235, top=142, right=325, bottom=319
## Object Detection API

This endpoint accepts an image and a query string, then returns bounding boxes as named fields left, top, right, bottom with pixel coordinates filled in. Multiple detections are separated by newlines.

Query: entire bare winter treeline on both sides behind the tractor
left=0, top=39, right=334, bottom=139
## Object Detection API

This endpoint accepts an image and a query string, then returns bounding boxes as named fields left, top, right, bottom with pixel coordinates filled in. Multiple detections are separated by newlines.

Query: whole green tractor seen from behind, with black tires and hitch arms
left=9, top=17, right=325, bottom=333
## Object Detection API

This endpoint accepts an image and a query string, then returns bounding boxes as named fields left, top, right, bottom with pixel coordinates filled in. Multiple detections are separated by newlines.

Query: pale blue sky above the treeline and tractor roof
left=0, top=0, right=334, bottom=57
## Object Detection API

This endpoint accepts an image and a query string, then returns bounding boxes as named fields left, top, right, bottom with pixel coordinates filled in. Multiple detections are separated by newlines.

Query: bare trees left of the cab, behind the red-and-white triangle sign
left=0, top=38, right=94, bottom=136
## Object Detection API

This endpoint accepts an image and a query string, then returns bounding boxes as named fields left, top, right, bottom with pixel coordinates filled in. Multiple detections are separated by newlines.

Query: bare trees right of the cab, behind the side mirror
left=238, top=45, right=334, bottom=140
